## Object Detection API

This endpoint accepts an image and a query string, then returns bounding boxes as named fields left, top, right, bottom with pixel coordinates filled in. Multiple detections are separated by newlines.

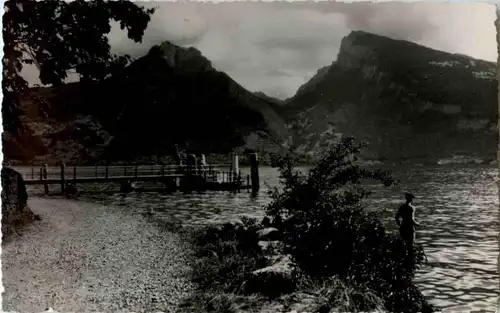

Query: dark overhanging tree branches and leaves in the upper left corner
left=2, top=0, right=154, bottom=131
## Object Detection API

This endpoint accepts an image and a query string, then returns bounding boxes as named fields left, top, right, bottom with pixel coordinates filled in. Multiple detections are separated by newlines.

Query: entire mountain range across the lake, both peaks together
left=3, top=31, right=497, bottom=163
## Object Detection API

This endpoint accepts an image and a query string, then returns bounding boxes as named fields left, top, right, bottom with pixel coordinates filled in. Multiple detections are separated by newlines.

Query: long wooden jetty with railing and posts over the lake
left=11, top=154, right=260, bottom=194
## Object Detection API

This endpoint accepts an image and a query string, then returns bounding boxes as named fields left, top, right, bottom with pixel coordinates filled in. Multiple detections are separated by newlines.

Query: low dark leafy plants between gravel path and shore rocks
left=181, top=218, right=274, bottom=313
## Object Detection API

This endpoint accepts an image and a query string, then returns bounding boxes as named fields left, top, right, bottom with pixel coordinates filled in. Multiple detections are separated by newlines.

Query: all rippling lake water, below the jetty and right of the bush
left=33, top=166, right=498, bottom=311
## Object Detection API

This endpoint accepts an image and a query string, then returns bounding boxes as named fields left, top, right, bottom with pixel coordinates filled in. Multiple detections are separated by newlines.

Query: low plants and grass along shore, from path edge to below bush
left=181, top=219, right=383, bottom=313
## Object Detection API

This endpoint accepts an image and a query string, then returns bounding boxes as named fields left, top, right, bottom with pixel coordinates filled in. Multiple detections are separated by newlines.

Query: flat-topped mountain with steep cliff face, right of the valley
left=284, top=31, right=497, bottom=162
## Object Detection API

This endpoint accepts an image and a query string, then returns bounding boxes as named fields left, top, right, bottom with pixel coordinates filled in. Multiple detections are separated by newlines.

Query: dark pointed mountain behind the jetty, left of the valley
left=4, top=42, right=288, bottom=163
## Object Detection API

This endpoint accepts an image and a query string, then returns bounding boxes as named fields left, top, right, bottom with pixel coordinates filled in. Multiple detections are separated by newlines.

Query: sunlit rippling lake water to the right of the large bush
left=366, top=167, right=498, bottom=311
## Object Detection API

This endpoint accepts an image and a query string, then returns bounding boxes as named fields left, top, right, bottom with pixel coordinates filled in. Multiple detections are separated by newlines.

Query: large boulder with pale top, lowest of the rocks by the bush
left=245, top=256, right=296, bottom=297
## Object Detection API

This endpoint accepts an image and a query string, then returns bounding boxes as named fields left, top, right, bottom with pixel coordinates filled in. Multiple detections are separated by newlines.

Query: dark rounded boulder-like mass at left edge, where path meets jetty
left=1, top=167, right=40, bottom=233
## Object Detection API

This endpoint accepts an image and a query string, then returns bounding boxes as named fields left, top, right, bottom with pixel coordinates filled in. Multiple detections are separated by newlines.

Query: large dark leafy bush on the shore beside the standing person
left=267, top=138, right=434, bottom=312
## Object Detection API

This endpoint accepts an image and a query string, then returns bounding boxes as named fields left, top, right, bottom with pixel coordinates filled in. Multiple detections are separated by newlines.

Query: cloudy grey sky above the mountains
left=21, top=1, right=497, bottom=99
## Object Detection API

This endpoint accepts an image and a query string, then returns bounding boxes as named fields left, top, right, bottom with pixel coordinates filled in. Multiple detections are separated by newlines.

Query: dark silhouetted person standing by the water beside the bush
left=396, top=193, right=420, bottom=260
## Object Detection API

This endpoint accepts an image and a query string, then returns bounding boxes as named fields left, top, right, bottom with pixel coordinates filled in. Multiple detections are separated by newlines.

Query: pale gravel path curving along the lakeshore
left=2, top=198, right=192, bottom=313
